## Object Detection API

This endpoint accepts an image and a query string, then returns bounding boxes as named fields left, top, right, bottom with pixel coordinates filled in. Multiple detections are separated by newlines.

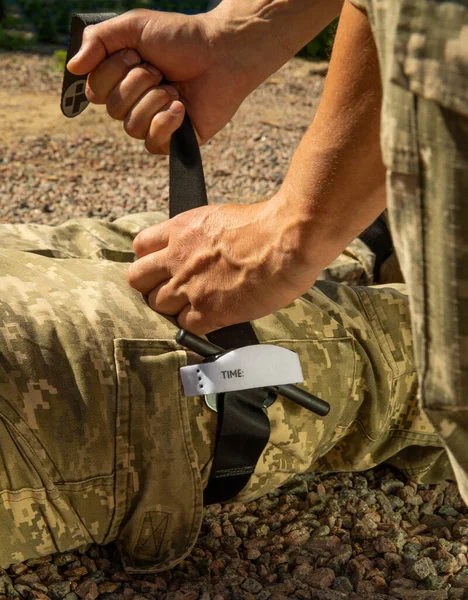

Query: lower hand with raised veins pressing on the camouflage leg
left=127, top=199, right=322, bottom=334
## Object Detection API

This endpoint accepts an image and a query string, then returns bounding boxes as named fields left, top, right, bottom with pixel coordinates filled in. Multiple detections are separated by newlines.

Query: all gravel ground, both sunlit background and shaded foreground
left=0, top=54, right=468, bottom=600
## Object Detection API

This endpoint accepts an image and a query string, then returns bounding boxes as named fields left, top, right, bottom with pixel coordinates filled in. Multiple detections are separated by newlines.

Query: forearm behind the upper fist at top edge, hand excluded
left=208, top=0, right=343, bottom=92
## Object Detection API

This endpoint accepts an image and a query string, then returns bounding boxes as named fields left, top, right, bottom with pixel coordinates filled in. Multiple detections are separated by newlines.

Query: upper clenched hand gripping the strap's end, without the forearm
left=68, top=10, right=250, bottom=154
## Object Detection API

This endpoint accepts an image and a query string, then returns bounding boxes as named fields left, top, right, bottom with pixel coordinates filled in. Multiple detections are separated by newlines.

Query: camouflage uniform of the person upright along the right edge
left=351, top=0, right=468, bottom=503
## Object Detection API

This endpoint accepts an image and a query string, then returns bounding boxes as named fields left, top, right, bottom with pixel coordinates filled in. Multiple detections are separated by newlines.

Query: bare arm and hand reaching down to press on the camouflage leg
left=128, top=4, right=385, bottom=333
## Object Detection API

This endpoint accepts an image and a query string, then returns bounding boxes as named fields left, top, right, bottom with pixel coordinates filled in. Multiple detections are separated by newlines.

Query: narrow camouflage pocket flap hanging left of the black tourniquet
left=110, top=339, right=203, bottom=573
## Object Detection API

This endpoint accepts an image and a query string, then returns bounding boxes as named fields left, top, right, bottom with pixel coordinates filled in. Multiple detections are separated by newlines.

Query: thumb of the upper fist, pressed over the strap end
left=67, top=10, right=150, bottom=75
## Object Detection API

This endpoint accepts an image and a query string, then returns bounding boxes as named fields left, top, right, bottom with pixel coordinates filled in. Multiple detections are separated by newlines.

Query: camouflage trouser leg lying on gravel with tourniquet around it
left=0, top=213, right=452, bottom=572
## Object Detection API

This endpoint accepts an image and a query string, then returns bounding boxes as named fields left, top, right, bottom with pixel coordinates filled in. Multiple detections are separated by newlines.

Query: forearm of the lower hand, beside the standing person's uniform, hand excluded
left=279, top=4, right=386, bottom=266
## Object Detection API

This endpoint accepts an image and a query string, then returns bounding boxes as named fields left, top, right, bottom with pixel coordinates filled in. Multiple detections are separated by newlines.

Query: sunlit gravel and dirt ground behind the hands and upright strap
left=0, top=53, right=327, bottom=224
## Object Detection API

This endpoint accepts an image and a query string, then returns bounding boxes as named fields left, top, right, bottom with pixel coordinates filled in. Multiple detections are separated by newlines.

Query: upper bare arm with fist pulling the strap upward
left=68, top=0, right=342, bottom=154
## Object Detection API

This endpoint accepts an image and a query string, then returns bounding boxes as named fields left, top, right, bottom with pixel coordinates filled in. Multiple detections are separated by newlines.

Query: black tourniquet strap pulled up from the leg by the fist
left=62, top=14, right=270, bottom=504
